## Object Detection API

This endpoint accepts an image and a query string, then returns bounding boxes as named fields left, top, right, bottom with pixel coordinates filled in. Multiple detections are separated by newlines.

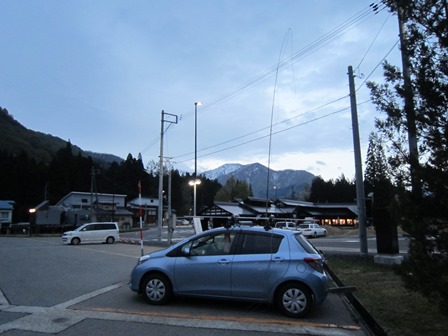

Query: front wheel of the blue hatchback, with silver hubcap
left=143, top=274, right=173, bottom=306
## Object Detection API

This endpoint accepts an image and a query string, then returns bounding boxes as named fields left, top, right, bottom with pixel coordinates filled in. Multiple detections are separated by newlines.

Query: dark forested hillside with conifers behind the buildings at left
left=0, top=108, right=221, bottom=222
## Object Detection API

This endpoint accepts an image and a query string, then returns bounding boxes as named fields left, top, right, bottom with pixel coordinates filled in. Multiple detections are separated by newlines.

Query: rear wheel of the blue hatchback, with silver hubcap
left=276, top=283, right=313, bottom=317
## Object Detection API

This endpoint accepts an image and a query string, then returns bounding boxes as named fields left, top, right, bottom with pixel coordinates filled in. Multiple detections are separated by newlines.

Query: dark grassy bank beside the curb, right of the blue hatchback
left=326, top=254, right=448, bottom=336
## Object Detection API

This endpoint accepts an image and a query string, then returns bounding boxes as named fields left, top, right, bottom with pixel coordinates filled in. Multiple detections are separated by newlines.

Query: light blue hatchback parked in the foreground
left=129, top=226, right=328, bottom=317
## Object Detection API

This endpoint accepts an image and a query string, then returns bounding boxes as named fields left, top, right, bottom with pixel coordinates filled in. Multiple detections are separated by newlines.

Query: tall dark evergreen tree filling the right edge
left=369, top=0, right=448, bottom=313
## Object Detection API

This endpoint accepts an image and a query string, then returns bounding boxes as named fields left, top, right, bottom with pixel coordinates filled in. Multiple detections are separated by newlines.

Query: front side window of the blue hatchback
left=183, top=231, right=235, bottom=256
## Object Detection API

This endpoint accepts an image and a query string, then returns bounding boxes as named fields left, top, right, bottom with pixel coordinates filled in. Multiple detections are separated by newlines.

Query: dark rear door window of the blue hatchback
left=238, top=233, right=283, bottom=254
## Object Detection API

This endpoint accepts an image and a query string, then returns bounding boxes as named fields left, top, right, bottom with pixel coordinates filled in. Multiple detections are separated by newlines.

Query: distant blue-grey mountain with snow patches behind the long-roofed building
left=202, top=163, right=315, bottom=199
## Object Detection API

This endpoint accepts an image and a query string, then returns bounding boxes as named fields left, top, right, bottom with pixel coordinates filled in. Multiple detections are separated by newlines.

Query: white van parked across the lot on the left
left=62, top=222, right=120, bottom=245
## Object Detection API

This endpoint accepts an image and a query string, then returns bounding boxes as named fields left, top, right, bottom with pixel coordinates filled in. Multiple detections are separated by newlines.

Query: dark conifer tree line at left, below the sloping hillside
left=0, top=142, right=221, bottom=223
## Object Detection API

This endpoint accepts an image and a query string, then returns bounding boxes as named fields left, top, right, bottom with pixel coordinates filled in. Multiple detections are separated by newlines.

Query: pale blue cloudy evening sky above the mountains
left=0, top=0, right=401, bottom=180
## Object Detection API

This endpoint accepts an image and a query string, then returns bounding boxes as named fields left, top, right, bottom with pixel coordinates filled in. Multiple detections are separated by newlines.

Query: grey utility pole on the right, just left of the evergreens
left=348, top=65, right=368, bottom=255
